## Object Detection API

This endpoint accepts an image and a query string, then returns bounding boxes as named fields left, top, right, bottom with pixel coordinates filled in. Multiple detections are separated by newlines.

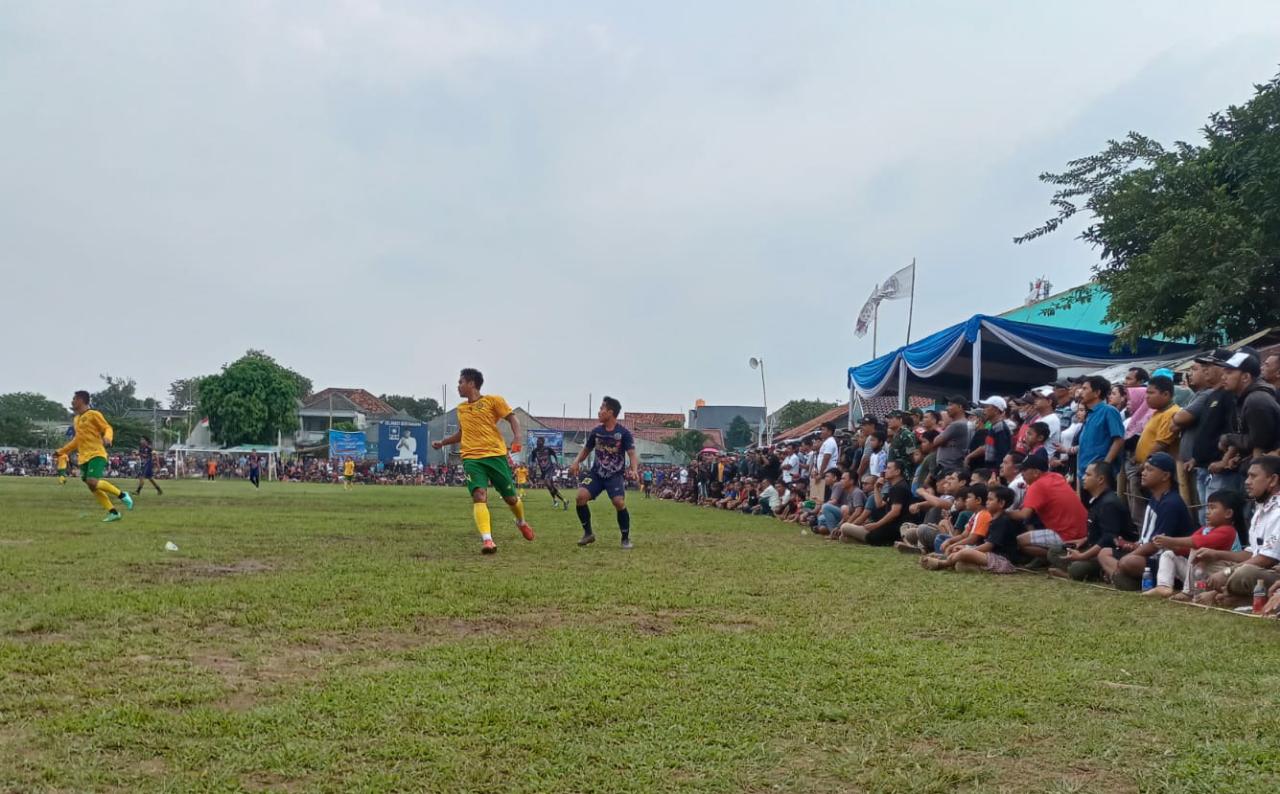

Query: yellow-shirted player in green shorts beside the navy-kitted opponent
left=431, top=368, right=534, bottom=555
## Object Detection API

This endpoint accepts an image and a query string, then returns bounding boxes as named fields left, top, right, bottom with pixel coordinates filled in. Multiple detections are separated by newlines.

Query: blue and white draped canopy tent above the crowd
left=849, top=314, right=1197, bottom=402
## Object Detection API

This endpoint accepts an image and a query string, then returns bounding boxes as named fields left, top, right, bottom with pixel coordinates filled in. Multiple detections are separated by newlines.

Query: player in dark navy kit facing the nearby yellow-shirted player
left=568, top=397, right=640, bottom=548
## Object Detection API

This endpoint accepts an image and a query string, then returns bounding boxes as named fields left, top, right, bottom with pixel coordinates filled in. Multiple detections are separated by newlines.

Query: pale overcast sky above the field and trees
left=0, top=0, right=1280, bottom=415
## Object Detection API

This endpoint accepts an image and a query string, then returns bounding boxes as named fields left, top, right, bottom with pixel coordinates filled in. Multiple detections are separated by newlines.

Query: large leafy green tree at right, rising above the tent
left=1014, top=77, right=1280, bottom=344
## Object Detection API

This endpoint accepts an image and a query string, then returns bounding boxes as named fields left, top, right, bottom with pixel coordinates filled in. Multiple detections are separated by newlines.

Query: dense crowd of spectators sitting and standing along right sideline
left=646, top=348, right=1280, bottom=613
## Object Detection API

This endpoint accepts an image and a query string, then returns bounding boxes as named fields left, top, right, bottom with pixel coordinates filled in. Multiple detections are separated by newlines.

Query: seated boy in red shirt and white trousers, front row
left=1143, top=490, right=1248, bottom=601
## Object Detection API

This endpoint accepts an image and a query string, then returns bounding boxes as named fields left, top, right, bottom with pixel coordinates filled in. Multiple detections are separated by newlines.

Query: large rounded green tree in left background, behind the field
left=198, top=351, right=302, bottom=446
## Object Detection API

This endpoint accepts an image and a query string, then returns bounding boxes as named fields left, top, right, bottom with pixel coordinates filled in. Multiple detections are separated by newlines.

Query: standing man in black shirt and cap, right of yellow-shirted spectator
left=1174, top=348, right=1243, bottom=524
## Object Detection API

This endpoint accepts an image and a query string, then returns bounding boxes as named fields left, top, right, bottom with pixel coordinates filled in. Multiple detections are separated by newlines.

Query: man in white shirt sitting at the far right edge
left=1196, top=455, right=1280, bottom=607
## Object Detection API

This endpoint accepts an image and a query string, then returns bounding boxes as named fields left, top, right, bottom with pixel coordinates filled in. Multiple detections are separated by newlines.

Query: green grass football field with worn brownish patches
left=0, top=478, right=1280, bottom=794
